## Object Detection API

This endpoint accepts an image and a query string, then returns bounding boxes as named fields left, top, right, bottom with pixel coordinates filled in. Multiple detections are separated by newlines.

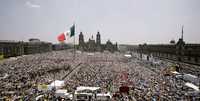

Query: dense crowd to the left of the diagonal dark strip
left=0, top=51, right=76, bottom=99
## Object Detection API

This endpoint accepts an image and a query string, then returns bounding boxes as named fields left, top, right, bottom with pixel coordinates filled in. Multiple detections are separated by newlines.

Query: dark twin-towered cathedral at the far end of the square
left=78, top=32, right=118, bottom=52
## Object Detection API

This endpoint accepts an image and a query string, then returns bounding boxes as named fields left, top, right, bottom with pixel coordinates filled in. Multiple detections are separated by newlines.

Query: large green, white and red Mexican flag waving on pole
left=57, top=25, right=75, bottom=42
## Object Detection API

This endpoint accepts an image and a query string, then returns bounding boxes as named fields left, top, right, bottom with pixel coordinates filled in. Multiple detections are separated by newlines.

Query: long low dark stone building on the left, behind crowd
left=0, top=39, right=52, bottom=58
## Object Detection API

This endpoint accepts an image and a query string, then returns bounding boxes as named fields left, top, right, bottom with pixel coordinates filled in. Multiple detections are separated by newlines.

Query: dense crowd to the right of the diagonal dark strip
left=67, top=53, right=200, bottom=101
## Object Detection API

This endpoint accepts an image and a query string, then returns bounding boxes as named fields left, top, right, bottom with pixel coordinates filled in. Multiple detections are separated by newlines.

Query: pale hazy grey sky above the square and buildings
left=0, top=0, right=200, bottom=44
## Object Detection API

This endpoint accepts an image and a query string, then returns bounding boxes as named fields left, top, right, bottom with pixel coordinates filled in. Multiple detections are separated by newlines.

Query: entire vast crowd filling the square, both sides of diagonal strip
left=0, top=50, right=199, bottom=101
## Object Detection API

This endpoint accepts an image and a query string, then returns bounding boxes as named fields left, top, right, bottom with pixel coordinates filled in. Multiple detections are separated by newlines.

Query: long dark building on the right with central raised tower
left=133, top=34, right=200, bottom=65
